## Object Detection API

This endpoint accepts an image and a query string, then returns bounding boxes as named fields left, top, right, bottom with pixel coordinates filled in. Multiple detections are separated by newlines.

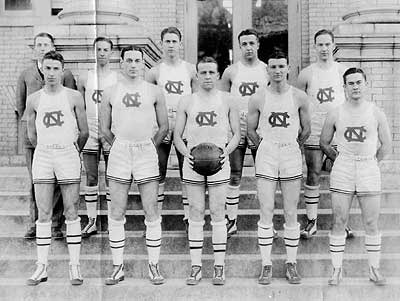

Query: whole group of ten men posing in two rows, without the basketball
left=17, top=27, right=391, bottom=285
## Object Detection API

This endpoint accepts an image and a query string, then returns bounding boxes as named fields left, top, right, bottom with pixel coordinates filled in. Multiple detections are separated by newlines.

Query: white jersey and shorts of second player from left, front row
left=107, top=81, right=159, bottom=184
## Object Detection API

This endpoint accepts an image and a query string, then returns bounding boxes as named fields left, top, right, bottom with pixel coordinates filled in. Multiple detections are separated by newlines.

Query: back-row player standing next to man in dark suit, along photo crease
left=78, top=37, right=117, bottom=238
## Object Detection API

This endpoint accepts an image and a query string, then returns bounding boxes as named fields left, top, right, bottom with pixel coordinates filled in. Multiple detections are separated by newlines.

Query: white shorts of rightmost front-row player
left=330, top=154, right=381, bottom=195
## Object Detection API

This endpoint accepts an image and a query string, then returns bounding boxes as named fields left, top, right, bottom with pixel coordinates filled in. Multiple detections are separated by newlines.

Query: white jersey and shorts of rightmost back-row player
left=304, top=62, right=345, bottom=149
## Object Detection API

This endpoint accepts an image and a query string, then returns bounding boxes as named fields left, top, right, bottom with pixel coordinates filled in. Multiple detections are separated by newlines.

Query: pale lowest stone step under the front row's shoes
left=0, top=273, right=400, bottom=301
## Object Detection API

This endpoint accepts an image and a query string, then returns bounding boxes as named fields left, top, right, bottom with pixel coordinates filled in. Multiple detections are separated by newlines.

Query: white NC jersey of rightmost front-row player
left=335, top=102, right=378, bottom=156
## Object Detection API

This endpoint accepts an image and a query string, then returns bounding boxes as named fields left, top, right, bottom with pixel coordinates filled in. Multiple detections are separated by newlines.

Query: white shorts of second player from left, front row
left=107, top=139, right=160, bottom=184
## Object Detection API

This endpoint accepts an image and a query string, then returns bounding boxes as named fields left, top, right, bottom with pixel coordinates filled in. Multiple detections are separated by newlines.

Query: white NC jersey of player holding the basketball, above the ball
left=185, top=91, right=230, bottom=148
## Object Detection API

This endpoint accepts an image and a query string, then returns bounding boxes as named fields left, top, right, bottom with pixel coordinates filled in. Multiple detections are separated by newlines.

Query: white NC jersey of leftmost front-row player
left=35, top=87, right=78, bottom=145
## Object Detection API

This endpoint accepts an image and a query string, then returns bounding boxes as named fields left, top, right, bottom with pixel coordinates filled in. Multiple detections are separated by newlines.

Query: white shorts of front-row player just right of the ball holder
left=255, top=139, right=303, bottom=181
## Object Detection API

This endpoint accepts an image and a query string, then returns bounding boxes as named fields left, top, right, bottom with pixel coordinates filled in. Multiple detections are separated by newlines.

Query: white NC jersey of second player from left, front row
left=110, top=81, right=156, bottom=142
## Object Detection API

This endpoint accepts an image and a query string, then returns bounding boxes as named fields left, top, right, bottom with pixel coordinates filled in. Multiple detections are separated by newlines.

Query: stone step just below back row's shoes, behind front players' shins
left=0, top=230, right=400, bottom=256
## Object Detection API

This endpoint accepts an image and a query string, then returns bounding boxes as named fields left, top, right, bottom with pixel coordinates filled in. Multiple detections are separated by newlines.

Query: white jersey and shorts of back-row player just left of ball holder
left=157, top=61, right=192, bottom=143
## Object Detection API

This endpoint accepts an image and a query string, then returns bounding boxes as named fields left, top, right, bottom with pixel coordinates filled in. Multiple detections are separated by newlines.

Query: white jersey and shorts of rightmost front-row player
left=330, top=102, right=381, bottom=194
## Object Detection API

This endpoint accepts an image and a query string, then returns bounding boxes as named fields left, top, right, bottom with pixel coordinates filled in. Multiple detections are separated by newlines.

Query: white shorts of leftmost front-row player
left=32, top=144, right=82, bottom=184
